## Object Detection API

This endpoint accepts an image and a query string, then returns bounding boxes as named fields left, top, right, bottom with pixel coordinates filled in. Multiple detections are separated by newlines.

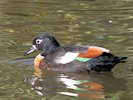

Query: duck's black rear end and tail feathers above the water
left=88, top=53, right=127, bottom=72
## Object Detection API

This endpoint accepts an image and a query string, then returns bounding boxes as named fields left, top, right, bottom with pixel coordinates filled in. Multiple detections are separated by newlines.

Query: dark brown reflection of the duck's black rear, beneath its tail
left=83, top=73, right=127, bottom=93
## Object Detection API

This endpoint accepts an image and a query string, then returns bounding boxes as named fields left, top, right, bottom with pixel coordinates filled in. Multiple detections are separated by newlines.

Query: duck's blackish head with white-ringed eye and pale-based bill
left=24, top=33, right=60, bottom=55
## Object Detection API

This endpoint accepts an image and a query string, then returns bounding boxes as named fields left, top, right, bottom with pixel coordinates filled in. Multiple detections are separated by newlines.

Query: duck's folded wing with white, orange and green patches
left=56, top=46, right=109, bottom=64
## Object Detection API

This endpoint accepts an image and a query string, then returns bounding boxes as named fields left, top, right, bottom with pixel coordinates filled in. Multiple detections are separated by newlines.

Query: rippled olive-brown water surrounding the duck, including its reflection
left=0, top=0, right=133, bottom=100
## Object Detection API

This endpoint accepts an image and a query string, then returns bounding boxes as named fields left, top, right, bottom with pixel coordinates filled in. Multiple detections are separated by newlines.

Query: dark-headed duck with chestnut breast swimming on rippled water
left=24, top=33, right=127, bottom=72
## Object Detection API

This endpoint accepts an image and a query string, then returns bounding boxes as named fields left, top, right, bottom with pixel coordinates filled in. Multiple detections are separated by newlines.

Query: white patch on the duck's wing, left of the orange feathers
left=56, top=52, right=79, bottom=64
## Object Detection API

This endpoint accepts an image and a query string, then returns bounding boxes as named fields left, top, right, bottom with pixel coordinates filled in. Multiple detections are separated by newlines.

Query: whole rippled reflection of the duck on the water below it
left=29, top=71, right=127, bottom=98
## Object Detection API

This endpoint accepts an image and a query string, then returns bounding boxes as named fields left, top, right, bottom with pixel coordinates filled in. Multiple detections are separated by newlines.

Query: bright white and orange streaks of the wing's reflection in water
left=58, top=78, right=105, bottom=98
